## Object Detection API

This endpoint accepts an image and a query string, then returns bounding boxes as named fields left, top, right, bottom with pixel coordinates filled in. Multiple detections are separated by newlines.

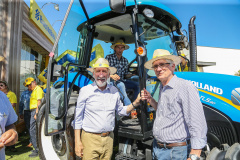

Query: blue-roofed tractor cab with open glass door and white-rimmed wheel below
left=38, top=0, right=188, bottom=159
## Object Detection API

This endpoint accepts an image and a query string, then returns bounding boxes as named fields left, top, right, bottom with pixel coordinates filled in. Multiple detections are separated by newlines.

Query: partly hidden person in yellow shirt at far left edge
left=0, top=80, right=17, bottom=112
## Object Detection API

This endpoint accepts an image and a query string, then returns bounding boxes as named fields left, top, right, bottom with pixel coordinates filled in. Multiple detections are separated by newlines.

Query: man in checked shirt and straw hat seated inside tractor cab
left=106, top=39, right=139, bottom=105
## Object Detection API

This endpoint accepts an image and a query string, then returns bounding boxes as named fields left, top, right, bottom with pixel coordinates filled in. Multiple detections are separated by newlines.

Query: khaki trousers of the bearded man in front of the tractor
left=81, top=130, right=114, bottom=160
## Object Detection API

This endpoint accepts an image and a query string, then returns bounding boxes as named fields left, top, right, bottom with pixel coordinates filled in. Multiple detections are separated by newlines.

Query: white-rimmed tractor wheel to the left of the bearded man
left=37, top=108, right=73, bottom=160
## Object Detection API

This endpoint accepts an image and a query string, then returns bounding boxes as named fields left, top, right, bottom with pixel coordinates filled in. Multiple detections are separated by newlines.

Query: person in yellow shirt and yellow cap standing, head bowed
left=25, top=77, right=44, bottom=157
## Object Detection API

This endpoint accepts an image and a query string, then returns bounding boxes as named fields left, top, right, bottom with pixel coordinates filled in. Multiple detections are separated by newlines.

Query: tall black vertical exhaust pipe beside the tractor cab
left=188, top=16, right=197, bottom=72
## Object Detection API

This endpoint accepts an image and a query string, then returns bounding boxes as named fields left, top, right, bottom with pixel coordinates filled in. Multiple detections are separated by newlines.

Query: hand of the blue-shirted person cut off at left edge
left=0, top=129, right=18, bottom=149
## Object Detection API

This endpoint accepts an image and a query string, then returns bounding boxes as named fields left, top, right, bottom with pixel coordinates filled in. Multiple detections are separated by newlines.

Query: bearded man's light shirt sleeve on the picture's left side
left=73, top=88, right=87, bottom=129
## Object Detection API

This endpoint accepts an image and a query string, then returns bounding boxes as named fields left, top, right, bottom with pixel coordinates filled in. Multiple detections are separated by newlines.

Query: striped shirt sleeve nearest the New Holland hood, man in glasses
left=182, top=83, right=207, bottom=149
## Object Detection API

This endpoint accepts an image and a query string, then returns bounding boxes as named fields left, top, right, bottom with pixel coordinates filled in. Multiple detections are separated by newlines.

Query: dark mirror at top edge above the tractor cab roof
left=109, top=0, right=126, bottom=13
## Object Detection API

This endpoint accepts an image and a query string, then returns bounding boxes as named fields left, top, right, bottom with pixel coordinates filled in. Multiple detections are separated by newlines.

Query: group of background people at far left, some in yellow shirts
left=0, top=77, right=44, bottom=160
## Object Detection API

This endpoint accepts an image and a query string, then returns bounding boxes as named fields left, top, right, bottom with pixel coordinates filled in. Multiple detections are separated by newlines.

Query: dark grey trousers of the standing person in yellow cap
left=30, top=109, right=38, bottom=152
